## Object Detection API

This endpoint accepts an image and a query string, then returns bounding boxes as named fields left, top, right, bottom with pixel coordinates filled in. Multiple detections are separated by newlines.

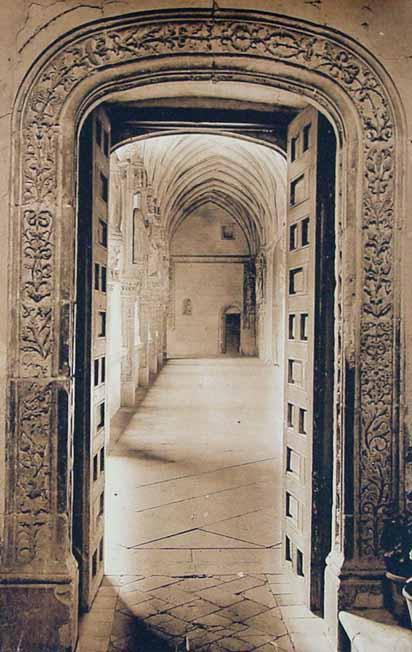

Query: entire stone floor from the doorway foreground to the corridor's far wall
left=80, top=358, right=331, bottom=652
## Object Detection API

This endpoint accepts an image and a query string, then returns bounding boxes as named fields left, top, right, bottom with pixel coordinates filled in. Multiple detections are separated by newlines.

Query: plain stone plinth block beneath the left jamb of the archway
left=0, top=571, right=78, bottom=652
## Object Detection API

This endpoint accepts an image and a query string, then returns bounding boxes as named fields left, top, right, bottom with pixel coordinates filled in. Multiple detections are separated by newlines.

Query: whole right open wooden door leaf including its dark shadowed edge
left=283, top=108, right=336, bottom=610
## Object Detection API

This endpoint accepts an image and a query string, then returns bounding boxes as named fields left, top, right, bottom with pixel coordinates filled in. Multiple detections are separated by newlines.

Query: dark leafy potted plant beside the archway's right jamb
left=382, top=512, right=412, bottom=627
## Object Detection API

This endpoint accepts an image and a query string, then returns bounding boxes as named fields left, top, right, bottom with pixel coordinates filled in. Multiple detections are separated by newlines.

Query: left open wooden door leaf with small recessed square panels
left=73, top=109, right=110, bottom=610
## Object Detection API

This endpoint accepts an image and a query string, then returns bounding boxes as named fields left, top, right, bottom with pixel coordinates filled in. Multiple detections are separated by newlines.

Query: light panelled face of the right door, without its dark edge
left=283, top=109, right=317, bottom=590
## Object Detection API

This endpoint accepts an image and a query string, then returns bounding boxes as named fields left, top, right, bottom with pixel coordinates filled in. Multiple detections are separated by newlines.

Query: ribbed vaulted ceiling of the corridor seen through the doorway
left=117, top=134, right=286, bottom=253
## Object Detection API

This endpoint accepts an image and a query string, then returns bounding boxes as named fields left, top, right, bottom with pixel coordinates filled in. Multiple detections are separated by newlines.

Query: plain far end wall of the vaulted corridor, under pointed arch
left=167, top=203, right=250, bottom=357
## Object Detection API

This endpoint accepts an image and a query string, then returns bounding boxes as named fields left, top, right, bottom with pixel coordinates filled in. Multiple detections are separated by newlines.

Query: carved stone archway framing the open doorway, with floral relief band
left=0, top=10, right=403, bottom=652
